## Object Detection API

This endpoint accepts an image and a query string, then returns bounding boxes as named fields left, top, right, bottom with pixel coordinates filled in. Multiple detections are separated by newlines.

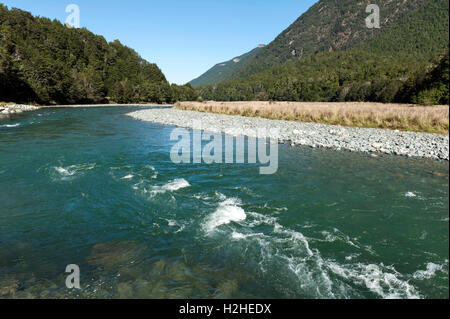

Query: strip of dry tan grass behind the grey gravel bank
left=175, top=102, right=449, bottom=134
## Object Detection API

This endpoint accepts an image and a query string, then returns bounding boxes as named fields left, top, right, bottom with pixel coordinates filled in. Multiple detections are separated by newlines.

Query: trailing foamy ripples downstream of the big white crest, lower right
left=221, top=212, right=422, bottom=299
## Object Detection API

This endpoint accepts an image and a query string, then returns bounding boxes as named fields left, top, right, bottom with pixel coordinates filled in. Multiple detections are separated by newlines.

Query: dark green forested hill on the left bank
left=0, top=4, right=195, bottom=104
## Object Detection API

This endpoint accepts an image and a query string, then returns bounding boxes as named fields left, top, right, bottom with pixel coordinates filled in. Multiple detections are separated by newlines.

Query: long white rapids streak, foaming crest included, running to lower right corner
left=197, top=193, right=432, bottom=299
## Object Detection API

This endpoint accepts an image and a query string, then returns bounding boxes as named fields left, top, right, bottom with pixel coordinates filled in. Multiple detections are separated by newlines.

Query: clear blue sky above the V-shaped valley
left=0, top=0, right=317, bottom=84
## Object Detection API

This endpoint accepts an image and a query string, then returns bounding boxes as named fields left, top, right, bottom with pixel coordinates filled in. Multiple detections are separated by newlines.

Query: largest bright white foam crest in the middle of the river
left=204, top=198, right=247, bottom=232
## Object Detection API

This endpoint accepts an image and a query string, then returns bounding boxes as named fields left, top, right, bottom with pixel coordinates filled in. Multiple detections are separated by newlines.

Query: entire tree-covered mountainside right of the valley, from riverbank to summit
left=196, top=0, right=449, bottom=105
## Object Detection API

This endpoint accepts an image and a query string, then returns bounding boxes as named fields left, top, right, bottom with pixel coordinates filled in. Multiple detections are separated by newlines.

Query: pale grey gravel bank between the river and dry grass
left=128, top=109, right=449, bottom=161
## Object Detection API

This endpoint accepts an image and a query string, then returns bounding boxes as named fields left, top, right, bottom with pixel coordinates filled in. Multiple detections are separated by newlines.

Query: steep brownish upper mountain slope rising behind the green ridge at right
left=232, top=0, right=428, bottom=79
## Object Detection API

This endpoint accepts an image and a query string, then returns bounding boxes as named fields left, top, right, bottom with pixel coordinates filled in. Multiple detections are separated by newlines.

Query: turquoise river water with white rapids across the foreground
left=0, top=107, right=449, bottom=298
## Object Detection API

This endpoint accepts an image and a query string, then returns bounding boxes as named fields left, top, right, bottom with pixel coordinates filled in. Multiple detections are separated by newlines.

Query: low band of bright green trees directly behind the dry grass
left=198, top=49, right=448, bottom=104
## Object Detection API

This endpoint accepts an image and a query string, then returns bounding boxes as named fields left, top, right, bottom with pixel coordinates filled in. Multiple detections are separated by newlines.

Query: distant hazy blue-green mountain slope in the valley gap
left=189, top=45, right=264, bottom=86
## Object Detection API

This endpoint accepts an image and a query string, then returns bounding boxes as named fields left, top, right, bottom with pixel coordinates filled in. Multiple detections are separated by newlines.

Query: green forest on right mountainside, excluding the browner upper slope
left=198, top=0, right=449, bottom=104
